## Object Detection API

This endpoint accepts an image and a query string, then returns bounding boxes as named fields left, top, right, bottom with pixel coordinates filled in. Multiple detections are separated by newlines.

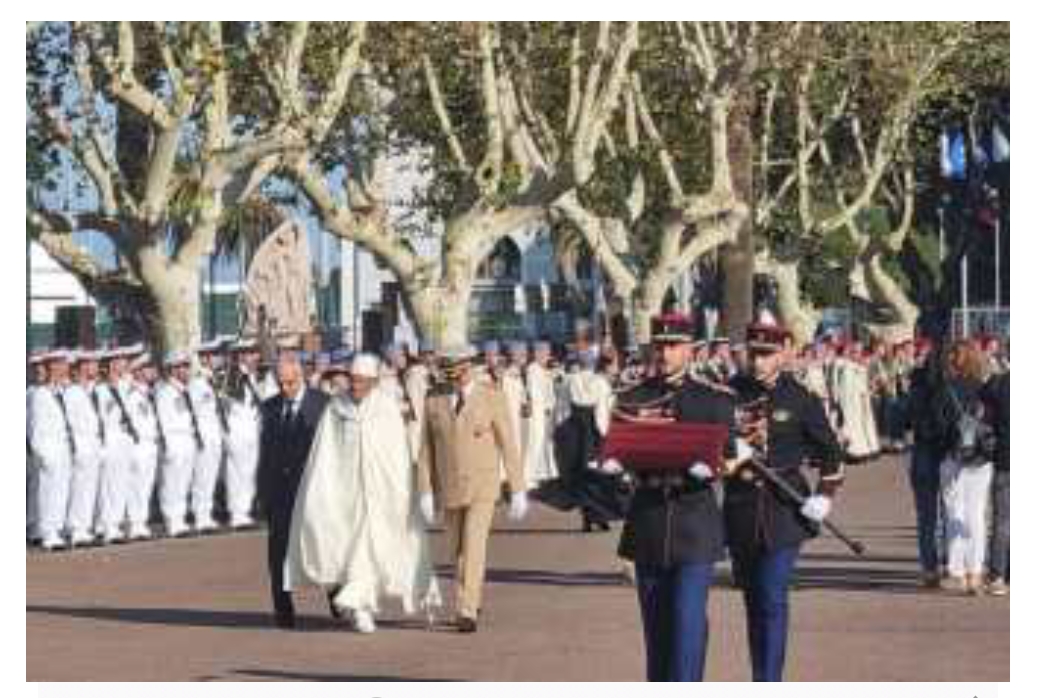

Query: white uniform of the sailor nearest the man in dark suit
left=225, top=368, right=264, bottom=527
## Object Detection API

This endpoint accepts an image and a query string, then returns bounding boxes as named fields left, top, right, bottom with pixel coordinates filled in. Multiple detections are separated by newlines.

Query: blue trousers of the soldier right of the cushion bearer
left=733, top=545, right=798, bottom=681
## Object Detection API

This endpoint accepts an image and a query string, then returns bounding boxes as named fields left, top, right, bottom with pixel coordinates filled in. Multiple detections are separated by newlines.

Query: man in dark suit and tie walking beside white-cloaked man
left=257, top=353, right=327, bottom=628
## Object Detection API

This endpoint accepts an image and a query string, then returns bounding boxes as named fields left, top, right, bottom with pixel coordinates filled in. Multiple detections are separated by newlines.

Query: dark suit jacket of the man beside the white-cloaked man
left=257, top=388, right=328, bottom=517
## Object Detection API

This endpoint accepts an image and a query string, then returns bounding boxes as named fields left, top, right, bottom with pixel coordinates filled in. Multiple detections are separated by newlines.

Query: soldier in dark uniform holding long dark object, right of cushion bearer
left=723, top=325, right=842, bottom=681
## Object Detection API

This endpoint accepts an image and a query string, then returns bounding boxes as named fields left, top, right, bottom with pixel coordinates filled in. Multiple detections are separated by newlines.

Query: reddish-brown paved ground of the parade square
left=26, top=453, right=1009, bottom=681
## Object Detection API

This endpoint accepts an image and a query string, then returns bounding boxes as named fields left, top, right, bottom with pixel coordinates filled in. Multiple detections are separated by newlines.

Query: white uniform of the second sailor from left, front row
left=66, top=383, right=105, bottom=544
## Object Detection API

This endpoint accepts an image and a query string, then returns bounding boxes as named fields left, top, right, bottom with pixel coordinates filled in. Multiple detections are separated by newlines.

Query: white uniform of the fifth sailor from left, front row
left=156, top=379, right=203, bottom=536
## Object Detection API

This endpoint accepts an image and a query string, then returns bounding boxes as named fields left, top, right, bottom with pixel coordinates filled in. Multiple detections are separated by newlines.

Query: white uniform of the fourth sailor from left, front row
left=126, top=381, right=160, bottom=538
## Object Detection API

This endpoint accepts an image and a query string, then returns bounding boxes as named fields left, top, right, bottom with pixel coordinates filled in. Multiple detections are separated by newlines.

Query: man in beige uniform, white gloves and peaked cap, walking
left=418, top=346, right=527, bottom=632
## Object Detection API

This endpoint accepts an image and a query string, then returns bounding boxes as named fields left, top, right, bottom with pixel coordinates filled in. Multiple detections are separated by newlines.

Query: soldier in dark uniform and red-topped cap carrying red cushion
left=618, top=316, right=736, bottom=681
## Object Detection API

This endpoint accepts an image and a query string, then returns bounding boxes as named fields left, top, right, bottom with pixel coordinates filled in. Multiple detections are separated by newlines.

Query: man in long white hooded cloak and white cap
left=286, top=354, right=441, bottom=633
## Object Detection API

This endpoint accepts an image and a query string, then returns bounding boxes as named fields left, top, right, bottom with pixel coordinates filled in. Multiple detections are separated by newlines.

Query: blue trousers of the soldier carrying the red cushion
left=635, top=562, right=715, bottom=681
